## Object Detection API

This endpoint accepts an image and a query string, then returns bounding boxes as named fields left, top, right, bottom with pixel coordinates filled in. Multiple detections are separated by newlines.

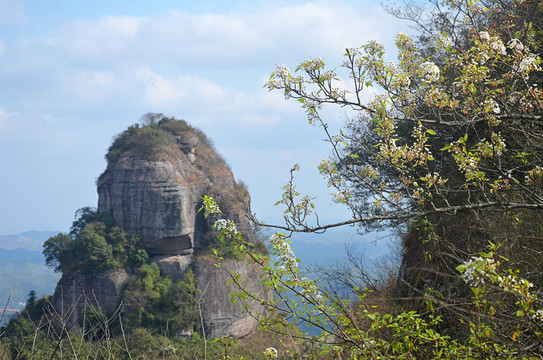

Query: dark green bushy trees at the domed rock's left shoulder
left=43, top=207, right=148, bottom=273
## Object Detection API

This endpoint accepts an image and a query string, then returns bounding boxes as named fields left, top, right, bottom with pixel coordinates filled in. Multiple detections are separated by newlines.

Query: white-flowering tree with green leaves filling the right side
left=207, top=0, right=543, bottom=358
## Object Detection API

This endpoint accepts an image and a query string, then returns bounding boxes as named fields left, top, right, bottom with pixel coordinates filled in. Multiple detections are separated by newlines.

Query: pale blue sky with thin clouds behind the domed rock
left=0, top=0, right=409, bottom=235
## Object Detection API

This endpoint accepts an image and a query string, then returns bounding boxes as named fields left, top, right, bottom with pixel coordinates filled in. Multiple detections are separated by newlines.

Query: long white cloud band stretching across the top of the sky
left=43, top=2, right=399, bottom=68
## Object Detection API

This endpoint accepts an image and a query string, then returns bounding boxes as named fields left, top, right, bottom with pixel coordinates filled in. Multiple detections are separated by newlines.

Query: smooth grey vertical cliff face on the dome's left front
left=98, top=158, right=209, bottom=255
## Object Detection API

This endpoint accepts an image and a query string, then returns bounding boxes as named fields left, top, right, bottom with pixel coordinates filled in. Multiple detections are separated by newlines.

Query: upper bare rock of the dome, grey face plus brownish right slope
left=98, top=126, right=252, bottom=256
